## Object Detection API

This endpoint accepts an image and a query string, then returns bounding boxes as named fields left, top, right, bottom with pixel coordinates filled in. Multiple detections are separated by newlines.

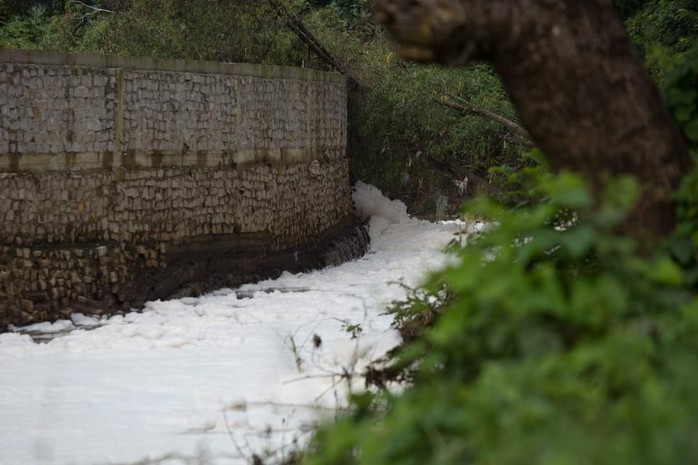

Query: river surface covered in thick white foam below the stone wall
left=0, top=185, right=476, bottom=465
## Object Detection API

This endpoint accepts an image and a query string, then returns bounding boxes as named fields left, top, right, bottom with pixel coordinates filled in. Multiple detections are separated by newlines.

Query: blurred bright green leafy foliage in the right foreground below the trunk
left=305, top=174, right=698, bottom=465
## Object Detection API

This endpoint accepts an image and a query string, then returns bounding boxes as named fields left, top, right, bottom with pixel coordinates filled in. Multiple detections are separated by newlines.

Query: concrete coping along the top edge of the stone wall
left=0, top=49, right=346, bottom=84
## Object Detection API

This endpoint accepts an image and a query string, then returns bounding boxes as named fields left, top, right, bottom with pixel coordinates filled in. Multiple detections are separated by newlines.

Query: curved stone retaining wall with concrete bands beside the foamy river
left=0, top=50, right=365, bottom=329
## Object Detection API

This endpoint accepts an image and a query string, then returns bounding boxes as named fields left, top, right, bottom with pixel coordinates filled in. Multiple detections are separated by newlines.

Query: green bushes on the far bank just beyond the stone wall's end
left=304, top=2, right=531, bottom=215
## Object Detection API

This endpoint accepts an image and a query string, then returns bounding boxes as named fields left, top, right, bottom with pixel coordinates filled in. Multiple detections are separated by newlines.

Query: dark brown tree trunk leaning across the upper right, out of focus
left=376, top=0, right=690, bottom=246
